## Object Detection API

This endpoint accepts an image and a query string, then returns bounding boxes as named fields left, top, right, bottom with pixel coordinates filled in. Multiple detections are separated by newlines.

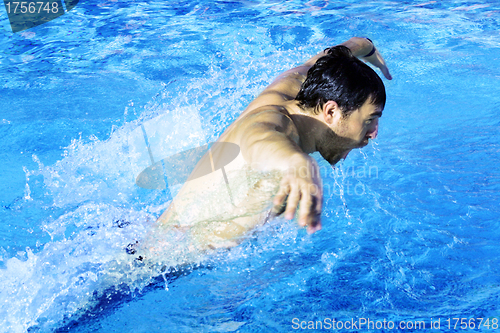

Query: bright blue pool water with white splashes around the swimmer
left=0, top=0, right=500, bottom=332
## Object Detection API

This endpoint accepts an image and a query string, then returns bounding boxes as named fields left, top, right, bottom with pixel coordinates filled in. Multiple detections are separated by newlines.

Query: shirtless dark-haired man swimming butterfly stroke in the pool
left=148, top=37, right=392, bottom=250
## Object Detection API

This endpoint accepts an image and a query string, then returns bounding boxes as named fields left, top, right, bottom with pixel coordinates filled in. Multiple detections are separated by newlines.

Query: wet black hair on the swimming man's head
left=295, top=45, right=386, bottom=116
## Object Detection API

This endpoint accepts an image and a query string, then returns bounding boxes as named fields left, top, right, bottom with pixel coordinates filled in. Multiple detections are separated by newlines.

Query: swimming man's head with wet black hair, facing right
left=295, top=46, right=386, bottom=164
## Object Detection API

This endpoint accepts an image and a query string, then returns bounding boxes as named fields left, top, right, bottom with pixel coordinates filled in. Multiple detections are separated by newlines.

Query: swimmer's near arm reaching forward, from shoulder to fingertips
left=231, top=108, right=323, bottom=233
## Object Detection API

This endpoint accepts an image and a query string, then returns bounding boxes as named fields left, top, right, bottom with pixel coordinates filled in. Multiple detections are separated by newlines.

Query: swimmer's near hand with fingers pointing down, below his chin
left=273, top=154, right=323, bottom=234
